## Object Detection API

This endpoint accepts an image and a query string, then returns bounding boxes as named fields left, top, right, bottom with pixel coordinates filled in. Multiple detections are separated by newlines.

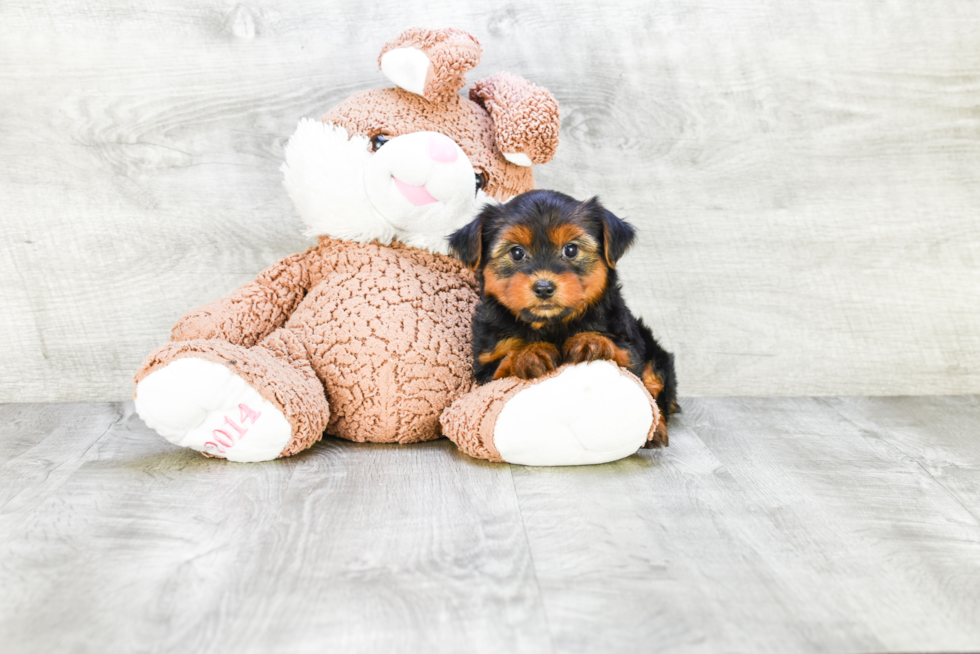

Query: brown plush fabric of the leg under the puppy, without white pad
left=441, top=365, right=660, bottom=461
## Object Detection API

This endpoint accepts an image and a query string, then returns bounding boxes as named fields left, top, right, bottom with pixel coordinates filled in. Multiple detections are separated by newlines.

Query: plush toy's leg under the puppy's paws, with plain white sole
left=441, top=361, right=660, bottom=466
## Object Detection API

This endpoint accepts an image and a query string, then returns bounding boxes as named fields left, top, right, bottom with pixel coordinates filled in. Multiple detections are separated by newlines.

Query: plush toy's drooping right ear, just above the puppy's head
left=470, top=73, right=560, bottom=166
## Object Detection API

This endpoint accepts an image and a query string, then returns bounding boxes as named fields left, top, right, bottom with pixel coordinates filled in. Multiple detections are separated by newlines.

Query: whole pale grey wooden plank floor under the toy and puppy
left=0, top=396, right=980, bottom=653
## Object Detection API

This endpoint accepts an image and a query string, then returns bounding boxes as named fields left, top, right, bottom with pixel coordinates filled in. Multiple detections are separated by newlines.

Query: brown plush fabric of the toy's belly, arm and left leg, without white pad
left=137, top=237, right=478, bottom=449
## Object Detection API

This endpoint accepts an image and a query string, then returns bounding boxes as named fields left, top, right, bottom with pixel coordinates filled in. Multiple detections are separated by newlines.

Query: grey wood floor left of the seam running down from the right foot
left=0, top=403, right=550, bottom=653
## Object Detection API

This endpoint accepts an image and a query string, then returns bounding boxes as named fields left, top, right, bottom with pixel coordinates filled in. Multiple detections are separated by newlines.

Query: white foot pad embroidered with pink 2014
left=135, top=358, right=292, bottom=462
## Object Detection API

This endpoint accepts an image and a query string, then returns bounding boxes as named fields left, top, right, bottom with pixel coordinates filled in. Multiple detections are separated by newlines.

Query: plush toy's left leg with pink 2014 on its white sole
left=134, top=329, right=330, bottom=461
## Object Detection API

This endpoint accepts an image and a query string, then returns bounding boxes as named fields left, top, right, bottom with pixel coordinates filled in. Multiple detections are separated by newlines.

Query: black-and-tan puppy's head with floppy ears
left=449, top=191, right=635, bottom=328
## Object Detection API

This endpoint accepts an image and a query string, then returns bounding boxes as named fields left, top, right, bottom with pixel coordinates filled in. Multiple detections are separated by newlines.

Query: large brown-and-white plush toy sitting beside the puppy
left=134, top=28, right=659, bottom=465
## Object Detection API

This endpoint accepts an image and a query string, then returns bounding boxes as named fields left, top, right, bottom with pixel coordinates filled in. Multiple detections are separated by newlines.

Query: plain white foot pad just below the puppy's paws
left=493, top=361, right=653, bottom=466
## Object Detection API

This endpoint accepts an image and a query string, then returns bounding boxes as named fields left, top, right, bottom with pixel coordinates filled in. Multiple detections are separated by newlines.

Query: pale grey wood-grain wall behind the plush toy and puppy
left=0, top=0, right=980, bottom=402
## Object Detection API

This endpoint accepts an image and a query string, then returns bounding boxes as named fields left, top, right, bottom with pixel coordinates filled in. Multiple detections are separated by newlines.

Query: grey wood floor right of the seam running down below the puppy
left=514, top=397, right=980, bottom=652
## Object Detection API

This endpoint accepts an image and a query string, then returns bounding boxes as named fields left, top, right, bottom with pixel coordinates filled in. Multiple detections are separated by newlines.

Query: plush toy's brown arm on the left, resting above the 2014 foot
left=170, top=248, right=315, bottom=347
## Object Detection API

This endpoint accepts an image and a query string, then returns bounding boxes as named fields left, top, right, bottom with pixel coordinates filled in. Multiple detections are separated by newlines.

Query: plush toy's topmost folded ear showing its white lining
left=378, top=27, right=483, bottom=102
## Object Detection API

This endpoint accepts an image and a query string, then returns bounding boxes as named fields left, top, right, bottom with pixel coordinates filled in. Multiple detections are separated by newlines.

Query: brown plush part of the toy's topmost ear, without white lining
left=378, top=27, right=483, bottom=103
